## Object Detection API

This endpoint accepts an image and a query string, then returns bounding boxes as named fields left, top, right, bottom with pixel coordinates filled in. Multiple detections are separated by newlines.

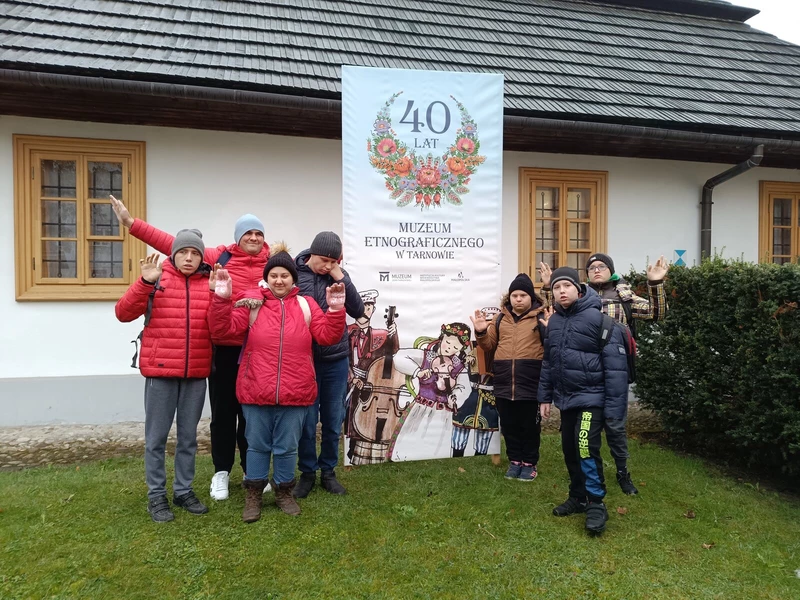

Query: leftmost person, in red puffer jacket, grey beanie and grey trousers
left=116, top=229, right=211, bottom=522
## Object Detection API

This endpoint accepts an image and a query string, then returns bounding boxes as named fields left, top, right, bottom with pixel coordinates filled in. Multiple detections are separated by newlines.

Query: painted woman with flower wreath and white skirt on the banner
left=389, top=323, right=472, bottom=461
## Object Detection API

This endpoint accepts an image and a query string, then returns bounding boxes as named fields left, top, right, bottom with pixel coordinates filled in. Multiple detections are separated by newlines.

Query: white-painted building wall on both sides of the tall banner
left=0, top=117, right=800, bottom=379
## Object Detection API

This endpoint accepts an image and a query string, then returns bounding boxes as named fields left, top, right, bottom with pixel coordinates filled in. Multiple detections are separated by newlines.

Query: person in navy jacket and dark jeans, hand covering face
left=294, top=231, right=364, bottom=498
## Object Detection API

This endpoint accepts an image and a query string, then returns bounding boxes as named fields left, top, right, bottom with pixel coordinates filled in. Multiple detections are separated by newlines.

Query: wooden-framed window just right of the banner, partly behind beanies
left=519, top=168, right=608, bottom=287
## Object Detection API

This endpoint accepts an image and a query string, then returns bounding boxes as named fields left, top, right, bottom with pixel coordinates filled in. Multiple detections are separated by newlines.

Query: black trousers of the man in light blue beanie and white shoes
left=208, top=346, right=247, bottom=472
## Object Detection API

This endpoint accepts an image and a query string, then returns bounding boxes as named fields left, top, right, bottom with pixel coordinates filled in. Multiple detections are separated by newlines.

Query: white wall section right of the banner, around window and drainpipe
left=503, top=152, right=800, bottom=281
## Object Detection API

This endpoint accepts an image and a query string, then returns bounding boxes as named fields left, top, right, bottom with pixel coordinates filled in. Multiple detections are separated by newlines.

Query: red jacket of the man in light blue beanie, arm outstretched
left=130, top=219, right=269, bottom=346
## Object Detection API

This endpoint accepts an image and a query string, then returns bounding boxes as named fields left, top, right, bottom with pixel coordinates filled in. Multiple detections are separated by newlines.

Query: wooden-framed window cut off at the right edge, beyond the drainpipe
left=758, top=181, right=800, bottom=265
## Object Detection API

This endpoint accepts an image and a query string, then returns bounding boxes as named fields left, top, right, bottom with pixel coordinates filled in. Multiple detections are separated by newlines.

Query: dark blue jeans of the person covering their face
left=298, top=356, right=350, bottom=473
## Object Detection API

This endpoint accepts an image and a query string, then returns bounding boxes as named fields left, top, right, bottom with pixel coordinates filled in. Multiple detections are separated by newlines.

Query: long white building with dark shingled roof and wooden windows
left=0, top=0, right=800, bottom=426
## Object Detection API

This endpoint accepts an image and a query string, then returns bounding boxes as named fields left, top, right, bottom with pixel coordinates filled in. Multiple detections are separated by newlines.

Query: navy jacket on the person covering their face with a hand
left=295, top=250, right=364, bottom=362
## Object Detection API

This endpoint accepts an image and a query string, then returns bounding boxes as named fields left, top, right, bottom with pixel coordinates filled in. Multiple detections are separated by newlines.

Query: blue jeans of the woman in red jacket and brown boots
left=242, top=404, right=308, bottom=484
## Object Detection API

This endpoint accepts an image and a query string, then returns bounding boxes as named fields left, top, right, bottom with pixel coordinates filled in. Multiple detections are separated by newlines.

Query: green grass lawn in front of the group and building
left=0, top=436, right=800, bottom=600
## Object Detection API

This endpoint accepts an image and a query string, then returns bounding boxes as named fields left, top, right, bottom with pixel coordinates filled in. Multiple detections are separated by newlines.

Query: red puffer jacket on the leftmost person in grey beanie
left=115, top=259, right=211, bottom=379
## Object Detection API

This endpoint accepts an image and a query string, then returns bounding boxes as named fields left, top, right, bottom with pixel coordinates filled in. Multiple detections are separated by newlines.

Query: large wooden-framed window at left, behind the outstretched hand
left=14, top=135, right=145, bottom=300
